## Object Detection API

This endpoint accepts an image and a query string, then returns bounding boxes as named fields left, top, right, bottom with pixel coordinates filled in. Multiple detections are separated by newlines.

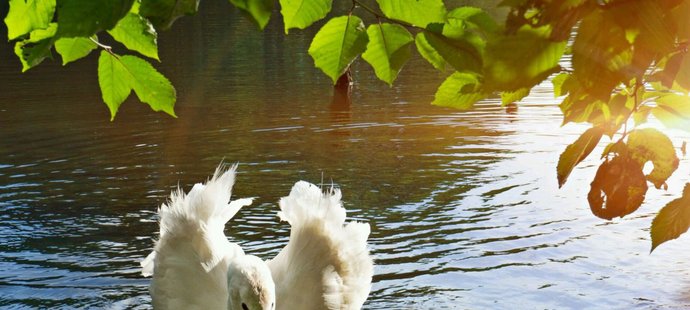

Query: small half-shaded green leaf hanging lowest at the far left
left=14, top=23, right=57, bottom=72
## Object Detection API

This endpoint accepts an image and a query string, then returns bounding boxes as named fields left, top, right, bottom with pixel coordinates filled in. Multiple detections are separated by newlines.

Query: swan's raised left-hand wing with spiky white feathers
left=142, top=166, right=251, bottom=309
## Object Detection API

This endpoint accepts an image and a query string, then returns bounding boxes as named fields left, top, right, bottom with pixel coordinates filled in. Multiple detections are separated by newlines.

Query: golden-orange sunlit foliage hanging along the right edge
left=528, top=0, right=690, bottom=250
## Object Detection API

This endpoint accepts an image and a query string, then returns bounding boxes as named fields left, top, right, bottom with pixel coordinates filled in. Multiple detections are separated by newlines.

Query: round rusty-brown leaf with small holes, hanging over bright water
left=587, top=155, right=647, bottom=220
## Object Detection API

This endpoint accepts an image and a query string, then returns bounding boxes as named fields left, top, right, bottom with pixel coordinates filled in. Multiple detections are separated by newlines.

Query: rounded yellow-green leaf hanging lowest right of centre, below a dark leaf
left=431, top=72, right=486, bottom=110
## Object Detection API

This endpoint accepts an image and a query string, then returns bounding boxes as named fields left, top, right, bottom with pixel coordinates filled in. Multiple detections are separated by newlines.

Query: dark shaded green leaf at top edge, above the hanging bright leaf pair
left=57, top=0, right=134, bottom=38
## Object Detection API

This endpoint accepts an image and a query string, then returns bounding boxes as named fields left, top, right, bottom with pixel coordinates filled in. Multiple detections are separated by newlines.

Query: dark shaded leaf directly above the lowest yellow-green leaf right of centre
left=417, top=30, right=482, bottom=73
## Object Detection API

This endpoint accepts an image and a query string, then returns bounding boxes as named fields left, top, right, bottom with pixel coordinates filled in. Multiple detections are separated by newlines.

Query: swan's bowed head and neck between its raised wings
left=228, top=255, right=276, bottom=310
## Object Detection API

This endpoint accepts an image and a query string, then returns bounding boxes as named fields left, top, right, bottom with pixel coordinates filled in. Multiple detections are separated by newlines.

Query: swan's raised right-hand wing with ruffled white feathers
left=268, top=181, right=373, bottom=309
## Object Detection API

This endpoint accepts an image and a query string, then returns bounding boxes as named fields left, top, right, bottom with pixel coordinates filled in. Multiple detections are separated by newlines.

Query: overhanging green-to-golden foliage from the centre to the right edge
left=286, top=0, right=690, bottom=252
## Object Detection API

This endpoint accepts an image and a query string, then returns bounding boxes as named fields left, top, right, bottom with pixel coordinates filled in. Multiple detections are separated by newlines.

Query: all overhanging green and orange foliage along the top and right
left=4, top=0, right=690, bottom=249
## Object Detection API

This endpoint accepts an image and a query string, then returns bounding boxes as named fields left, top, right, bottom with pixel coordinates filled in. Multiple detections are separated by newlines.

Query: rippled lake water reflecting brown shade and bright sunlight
left=0, top=1, right=690, bottom=309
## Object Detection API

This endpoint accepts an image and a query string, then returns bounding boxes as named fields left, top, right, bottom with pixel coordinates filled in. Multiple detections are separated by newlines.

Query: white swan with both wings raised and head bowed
left=141, top=165, right=373, bottom=310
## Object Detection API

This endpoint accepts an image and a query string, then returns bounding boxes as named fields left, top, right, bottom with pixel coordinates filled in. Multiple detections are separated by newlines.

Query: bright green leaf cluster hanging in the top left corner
left=4, top=0, right=176, bottom=119
